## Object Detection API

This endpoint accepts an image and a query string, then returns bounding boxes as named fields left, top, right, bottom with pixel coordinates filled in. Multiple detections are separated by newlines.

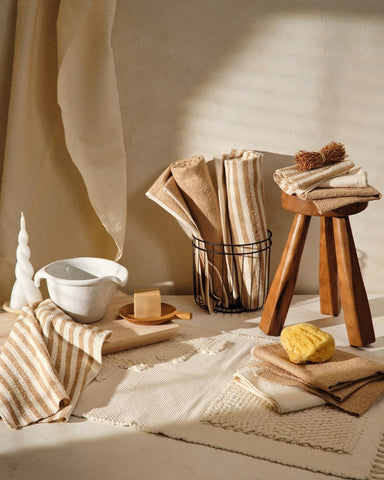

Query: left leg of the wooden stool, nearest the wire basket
left=259, top=213, right=311, bottom=336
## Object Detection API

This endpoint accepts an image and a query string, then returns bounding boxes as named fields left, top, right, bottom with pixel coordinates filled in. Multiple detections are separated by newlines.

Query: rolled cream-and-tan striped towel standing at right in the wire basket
left=224, top=150, right=268, bottom=309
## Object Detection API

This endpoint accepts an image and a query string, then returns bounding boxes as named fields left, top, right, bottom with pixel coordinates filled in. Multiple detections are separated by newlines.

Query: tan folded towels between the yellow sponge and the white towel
left=252, top=344, right=384, bottom=415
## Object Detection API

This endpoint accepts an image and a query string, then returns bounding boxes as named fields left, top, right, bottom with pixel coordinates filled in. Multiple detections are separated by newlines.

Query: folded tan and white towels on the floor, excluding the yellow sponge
left=235, top=343, right=384, bottom=416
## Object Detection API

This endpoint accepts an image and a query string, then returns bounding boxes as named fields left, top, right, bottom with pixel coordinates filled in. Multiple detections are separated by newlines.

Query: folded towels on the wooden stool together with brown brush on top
left=273, top=142, right=381, bottom=214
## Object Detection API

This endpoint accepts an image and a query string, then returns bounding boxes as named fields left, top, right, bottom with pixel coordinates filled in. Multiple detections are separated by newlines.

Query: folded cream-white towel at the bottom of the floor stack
left=233, top=366, right=326, bottom=413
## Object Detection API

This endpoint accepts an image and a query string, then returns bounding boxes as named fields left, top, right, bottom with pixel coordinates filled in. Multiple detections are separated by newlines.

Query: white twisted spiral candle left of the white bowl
left=9, top=213, right=42, bottom=310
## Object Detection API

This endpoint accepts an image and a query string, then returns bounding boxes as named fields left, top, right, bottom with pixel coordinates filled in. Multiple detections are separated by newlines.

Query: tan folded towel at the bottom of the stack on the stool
left=298, top=185, right=381, bottom=214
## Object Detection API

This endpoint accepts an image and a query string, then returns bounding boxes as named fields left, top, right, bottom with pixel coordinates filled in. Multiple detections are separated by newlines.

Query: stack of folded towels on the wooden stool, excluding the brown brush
left=273, top=156, right=381, bottom=215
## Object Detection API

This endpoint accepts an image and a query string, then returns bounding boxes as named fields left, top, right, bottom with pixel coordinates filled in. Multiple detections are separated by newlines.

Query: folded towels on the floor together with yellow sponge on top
left=234, top=323, right=384, bottom=416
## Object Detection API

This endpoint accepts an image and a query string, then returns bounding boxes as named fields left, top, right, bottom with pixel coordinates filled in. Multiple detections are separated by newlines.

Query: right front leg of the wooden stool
left=333, top=217, right=375, bottom=347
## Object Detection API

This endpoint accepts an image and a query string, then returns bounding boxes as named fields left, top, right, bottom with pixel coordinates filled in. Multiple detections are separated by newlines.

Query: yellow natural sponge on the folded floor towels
left=280, top=323, right=335, bottom=364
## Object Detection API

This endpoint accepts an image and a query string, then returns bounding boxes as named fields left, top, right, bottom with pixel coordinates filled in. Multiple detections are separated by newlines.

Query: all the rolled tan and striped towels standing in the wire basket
left=146, top=150, right=268, bottom=312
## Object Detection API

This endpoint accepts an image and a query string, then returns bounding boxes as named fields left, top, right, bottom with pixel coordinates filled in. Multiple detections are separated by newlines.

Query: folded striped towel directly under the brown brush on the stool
left=273, top=160, right=355, bottom=195
